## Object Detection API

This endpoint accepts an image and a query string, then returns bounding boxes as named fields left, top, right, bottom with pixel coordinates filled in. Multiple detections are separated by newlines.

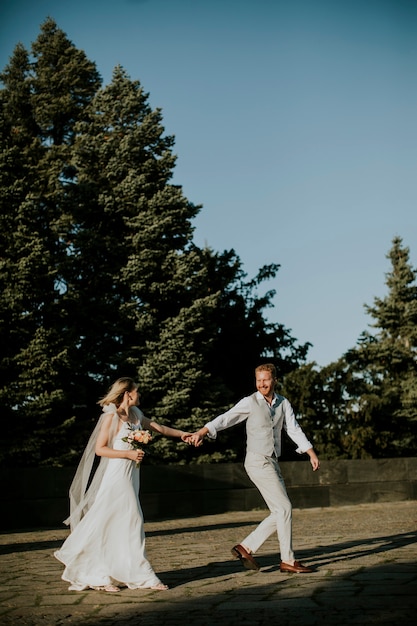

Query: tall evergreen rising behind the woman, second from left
left=66, top=67, right=223, bottom=460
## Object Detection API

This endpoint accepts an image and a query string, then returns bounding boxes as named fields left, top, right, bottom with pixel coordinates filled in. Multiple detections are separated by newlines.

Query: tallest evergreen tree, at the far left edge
left=0, top=20, right=99, bottom=463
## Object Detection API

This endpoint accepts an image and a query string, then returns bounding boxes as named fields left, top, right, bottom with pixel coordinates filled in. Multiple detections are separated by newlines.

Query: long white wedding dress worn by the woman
left=54, top=412, right=161, bottom=591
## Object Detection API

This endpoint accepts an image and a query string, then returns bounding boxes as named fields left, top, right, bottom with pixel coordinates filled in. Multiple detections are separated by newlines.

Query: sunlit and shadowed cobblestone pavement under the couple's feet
left=0, top=501, right=417, bottom=626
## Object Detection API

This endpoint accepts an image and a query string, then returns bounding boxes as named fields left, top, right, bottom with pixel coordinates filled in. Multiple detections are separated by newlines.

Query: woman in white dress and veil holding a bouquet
left=54, top=378, right=190, bottom=592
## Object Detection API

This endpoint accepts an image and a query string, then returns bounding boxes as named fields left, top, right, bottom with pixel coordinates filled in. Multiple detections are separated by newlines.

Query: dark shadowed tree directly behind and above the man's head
left=197, top=249, right=310, bottom=399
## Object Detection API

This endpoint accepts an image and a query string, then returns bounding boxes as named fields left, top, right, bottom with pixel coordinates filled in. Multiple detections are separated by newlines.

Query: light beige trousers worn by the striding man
left=241, top=452, right=294, bottom=563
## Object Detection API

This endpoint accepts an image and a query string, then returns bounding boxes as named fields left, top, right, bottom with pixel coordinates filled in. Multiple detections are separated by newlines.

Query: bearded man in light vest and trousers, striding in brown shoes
left=189, top=363, right=320, bottom=573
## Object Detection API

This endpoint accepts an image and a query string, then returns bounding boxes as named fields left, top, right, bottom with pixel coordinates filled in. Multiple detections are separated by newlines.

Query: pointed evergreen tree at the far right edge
left=344, top=237, right=417, bottom=458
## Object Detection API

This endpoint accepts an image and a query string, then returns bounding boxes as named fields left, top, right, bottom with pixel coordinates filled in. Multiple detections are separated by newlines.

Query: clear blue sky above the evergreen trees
left=0, top=0, right=417, bottom=365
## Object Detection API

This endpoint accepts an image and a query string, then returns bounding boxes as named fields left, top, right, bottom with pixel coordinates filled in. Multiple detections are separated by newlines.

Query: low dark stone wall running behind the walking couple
left=0, top=458, right=417, bottom=530
